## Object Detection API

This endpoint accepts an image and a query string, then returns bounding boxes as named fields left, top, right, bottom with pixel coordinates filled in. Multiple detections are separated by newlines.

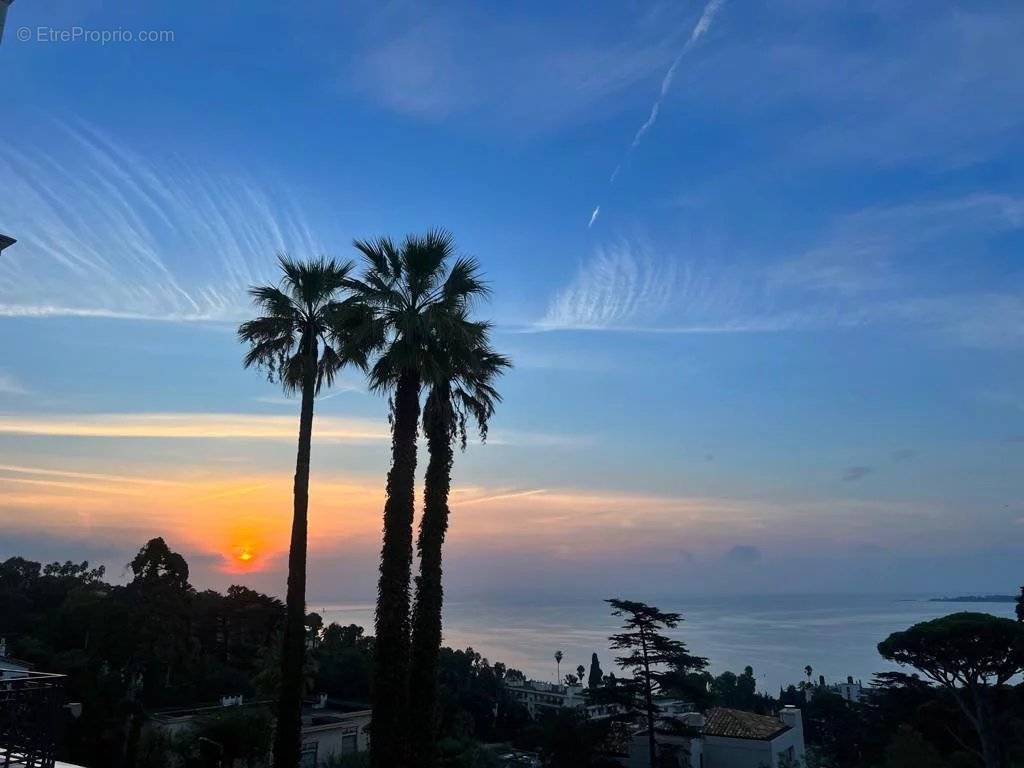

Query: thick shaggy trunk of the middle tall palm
left=370, top=373, right=420, bottom=768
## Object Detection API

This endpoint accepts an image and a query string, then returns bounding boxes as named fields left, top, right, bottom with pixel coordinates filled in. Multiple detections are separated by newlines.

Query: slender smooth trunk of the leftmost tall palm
left=273, top=340, right=316, bottom=768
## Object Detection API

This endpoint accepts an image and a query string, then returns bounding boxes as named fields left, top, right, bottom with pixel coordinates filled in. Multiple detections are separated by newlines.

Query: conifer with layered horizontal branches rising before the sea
left=605, top=599, right=708, bottom=768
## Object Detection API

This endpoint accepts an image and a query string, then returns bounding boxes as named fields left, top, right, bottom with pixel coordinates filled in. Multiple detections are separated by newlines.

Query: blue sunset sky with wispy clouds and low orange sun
left=0, top=0, right=1024, bottom=601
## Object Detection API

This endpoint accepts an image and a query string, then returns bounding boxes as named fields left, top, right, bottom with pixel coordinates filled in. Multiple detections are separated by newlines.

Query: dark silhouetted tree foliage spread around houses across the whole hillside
left=0, top=552, right=1024, bottom=768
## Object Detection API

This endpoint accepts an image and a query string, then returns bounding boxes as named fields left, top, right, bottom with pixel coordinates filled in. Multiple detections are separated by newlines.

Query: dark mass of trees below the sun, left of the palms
left=0, top=539, right=284, bottom=766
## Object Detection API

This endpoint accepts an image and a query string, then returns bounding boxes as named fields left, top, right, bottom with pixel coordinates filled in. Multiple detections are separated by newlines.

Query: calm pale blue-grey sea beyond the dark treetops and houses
left=310, top=595, right=1014, bottom=693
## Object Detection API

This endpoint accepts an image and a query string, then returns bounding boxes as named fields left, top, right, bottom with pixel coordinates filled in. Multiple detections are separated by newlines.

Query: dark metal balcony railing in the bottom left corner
left=0, top=672, right=65, bottom=768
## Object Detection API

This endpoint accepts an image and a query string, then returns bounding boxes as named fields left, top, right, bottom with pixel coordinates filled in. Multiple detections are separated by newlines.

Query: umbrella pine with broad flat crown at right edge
left=879, top=612, right=1024, bottom=768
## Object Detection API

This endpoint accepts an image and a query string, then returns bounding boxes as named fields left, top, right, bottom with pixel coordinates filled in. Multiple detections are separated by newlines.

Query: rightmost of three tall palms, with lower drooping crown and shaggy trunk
left=410, top=314, right=511, bottom=768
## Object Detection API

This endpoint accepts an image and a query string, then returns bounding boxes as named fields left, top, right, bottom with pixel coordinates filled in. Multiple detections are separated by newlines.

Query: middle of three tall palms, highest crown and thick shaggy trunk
left=354, top=229, right=486, bottom=768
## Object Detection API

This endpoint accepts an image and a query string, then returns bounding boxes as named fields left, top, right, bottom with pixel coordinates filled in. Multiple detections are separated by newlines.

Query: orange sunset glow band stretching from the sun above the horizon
left=0, top=464, right=937, bottom=581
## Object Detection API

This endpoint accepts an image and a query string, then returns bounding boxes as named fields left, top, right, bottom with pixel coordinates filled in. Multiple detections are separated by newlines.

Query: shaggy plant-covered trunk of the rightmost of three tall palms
left=410, top=388, right=454, bottom=768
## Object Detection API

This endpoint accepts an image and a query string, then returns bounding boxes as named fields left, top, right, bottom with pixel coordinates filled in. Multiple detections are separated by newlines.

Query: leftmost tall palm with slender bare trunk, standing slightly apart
left=239, top=255, right=372, bottom=768
